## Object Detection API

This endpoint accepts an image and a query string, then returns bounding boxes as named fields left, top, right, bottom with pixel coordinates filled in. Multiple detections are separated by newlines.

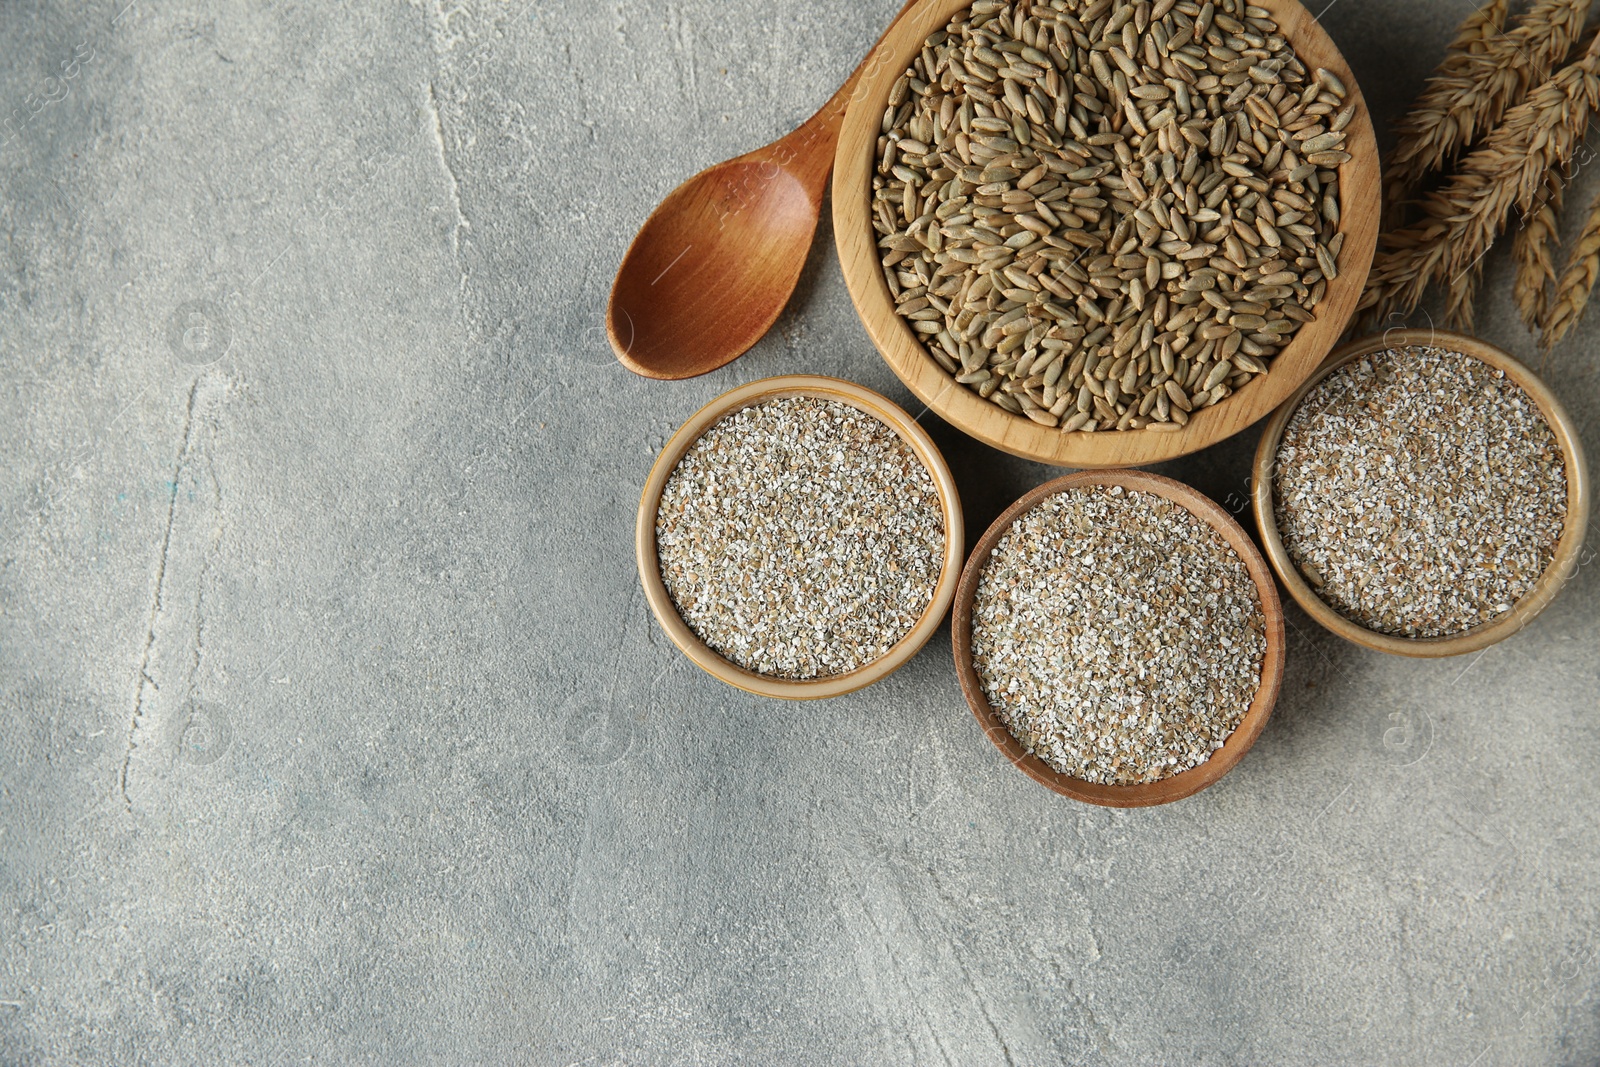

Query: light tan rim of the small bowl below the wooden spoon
left=634, top=374, right=966, bottom=701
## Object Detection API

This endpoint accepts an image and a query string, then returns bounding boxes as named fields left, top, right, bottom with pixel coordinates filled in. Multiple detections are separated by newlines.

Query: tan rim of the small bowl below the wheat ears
left=1250, top=330, right=1589, bottom=657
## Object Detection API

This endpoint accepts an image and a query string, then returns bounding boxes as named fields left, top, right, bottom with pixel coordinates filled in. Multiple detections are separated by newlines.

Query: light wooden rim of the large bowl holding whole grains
left=834, top=0, right=1379, bottom=467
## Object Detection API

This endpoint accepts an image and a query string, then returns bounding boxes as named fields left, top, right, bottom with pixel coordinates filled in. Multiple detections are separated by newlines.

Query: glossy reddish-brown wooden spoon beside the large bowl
left=605, top=0, right=917, bottom=379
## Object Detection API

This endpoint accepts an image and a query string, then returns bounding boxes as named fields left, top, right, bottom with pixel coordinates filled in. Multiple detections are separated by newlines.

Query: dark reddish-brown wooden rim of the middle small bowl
left=950, top=470, right=1283, bottom=808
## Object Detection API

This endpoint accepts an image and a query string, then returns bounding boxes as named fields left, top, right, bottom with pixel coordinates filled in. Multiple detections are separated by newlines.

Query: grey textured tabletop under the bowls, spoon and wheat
left=0, top=0, right=1600, bottom=1067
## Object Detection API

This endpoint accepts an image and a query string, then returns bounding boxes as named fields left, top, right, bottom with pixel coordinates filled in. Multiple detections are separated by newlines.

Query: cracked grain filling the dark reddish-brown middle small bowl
left=971, top=486, right=1267, bottom=785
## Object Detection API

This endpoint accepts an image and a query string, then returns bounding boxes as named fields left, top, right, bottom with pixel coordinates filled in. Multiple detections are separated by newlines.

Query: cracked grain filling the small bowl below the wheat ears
left=1272, top=347, right=1566, bottom=638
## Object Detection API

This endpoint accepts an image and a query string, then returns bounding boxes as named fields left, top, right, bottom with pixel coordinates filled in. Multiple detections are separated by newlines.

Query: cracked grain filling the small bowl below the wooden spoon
left=656, top=397, right=944, bottom=680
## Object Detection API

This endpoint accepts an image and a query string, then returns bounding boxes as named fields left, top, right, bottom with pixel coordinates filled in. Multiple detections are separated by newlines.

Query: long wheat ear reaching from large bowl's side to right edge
left=1362, top=37, right=1600, bottom=326
